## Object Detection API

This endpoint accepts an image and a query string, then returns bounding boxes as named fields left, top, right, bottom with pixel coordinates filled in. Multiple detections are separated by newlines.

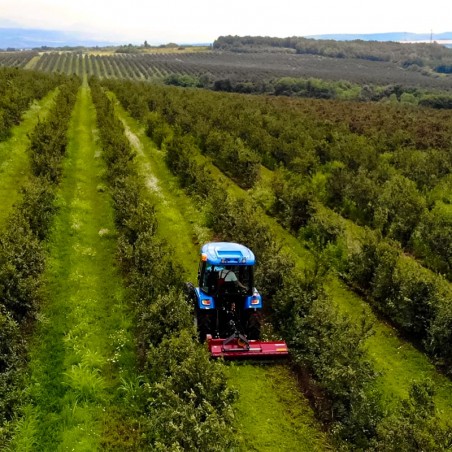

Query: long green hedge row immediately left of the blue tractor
left=90, top=80, right=236, bottom=451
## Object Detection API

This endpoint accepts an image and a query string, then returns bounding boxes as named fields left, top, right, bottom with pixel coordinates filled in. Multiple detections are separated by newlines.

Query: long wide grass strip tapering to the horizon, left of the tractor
left=15, top=83, right=139, bottom=451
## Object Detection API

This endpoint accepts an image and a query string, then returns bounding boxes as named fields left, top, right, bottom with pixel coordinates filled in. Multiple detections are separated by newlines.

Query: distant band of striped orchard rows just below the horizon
left=0, top=51, right=450, bottom=89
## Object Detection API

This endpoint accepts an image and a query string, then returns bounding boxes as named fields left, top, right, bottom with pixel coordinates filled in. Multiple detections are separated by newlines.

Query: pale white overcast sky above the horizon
left=0, top=0, right=452, bottom=44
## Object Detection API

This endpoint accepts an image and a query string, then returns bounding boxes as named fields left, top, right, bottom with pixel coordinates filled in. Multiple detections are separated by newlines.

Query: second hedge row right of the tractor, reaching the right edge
left=286, top=200, right=452, bottom=374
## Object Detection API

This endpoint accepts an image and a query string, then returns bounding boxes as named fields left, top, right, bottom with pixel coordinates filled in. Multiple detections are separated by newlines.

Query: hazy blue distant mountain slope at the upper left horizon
left=0, top=28, right=124, bottom=50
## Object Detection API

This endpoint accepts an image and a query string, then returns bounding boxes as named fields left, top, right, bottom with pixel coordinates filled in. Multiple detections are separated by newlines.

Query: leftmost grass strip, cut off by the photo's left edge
left=0, top=90, right=58, bottom=226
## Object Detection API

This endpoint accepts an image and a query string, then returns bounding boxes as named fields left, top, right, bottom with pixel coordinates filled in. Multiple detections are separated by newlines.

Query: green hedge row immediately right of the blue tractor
left=167, top=130, right=450, bottom=451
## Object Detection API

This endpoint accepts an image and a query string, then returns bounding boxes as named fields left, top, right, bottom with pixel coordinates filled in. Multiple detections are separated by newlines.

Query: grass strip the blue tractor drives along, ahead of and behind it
left=116, top=100, right=329, bottom=451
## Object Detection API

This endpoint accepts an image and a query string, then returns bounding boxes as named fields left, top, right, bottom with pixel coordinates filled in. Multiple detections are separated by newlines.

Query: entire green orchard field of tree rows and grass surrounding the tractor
left=0, top=38, right=452, bottom=451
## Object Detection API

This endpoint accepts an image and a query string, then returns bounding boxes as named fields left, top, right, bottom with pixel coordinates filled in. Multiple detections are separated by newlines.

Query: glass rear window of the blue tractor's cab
left=201, top=264, right=253, bottom=295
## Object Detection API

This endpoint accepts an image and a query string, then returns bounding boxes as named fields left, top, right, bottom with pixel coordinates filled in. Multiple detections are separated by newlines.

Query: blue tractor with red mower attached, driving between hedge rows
left=187, top=242, right=288, bottom=358
